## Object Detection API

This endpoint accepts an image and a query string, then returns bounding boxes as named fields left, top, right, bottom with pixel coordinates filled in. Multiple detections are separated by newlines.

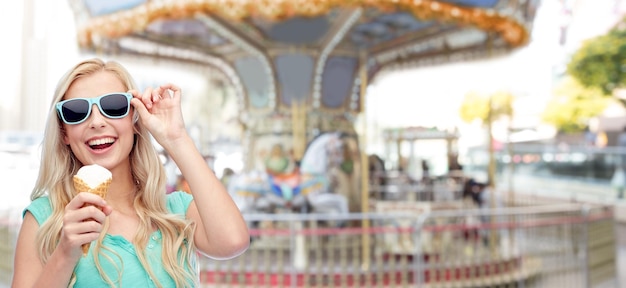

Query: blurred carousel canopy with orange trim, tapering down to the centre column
left=70, top=0, right=538, bottom=113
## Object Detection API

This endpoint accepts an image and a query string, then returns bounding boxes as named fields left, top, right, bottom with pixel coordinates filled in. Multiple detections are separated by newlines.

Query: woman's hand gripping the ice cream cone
left=58, top=192, right=113, bottom=259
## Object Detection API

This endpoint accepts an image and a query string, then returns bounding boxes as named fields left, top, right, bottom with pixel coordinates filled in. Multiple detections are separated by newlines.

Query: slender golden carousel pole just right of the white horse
left=359, top=51, right=370, bottom=270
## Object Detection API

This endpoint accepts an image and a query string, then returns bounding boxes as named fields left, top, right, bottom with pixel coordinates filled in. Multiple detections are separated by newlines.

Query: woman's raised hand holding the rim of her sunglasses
left=130, top=84, right=187, bottom=146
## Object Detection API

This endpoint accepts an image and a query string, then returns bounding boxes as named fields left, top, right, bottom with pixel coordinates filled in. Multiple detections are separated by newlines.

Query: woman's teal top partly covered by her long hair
left=24, top=192, right=193, bottom=288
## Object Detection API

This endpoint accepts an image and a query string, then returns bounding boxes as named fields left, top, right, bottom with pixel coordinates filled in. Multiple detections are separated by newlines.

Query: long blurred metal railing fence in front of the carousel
left=0, top=201, right=619, bottom=287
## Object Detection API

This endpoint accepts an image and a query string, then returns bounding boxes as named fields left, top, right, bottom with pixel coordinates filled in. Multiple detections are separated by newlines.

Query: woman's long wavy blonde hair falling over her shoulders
left=31, top=58, right=198, bottom=287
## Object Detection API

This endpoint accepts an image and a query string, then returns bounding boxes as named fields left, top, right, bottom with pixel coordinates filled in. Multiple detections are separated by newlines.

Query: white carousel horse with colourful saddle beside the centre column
left=228, top=133, right=348, bottom=213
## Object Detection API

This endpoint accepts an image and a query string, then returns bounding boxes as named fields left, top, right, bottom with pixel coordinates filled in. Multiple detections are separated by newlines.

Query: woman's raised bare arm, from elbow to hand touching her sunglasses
left=132, top=84, right=250, bottom=258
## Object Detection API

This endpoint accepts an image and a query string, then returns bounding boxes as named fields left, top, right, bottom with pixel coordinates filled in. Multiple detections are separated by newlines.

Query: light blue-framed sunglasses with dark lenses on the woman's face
left=56, top=93, right=133, bottom=125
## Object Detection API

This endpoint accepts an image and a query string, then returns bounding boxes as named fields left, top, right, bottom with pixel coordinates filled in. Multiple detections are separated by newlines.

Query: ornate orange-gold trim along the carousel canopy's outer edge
left=78, top=0, right=528, bottom=48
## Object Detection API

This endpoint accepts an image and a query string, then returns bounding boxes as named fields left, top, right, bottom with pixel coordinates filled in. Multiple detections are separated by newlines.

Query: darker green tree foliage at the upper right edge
left=567, top=20, right=626, bottom=95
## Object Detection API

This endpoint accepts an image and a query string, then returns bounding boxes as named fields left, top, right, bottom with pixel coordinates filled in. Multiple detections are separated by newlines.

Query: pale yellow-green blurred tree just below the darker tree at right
left=542, top=77, right=611, bottom=133
